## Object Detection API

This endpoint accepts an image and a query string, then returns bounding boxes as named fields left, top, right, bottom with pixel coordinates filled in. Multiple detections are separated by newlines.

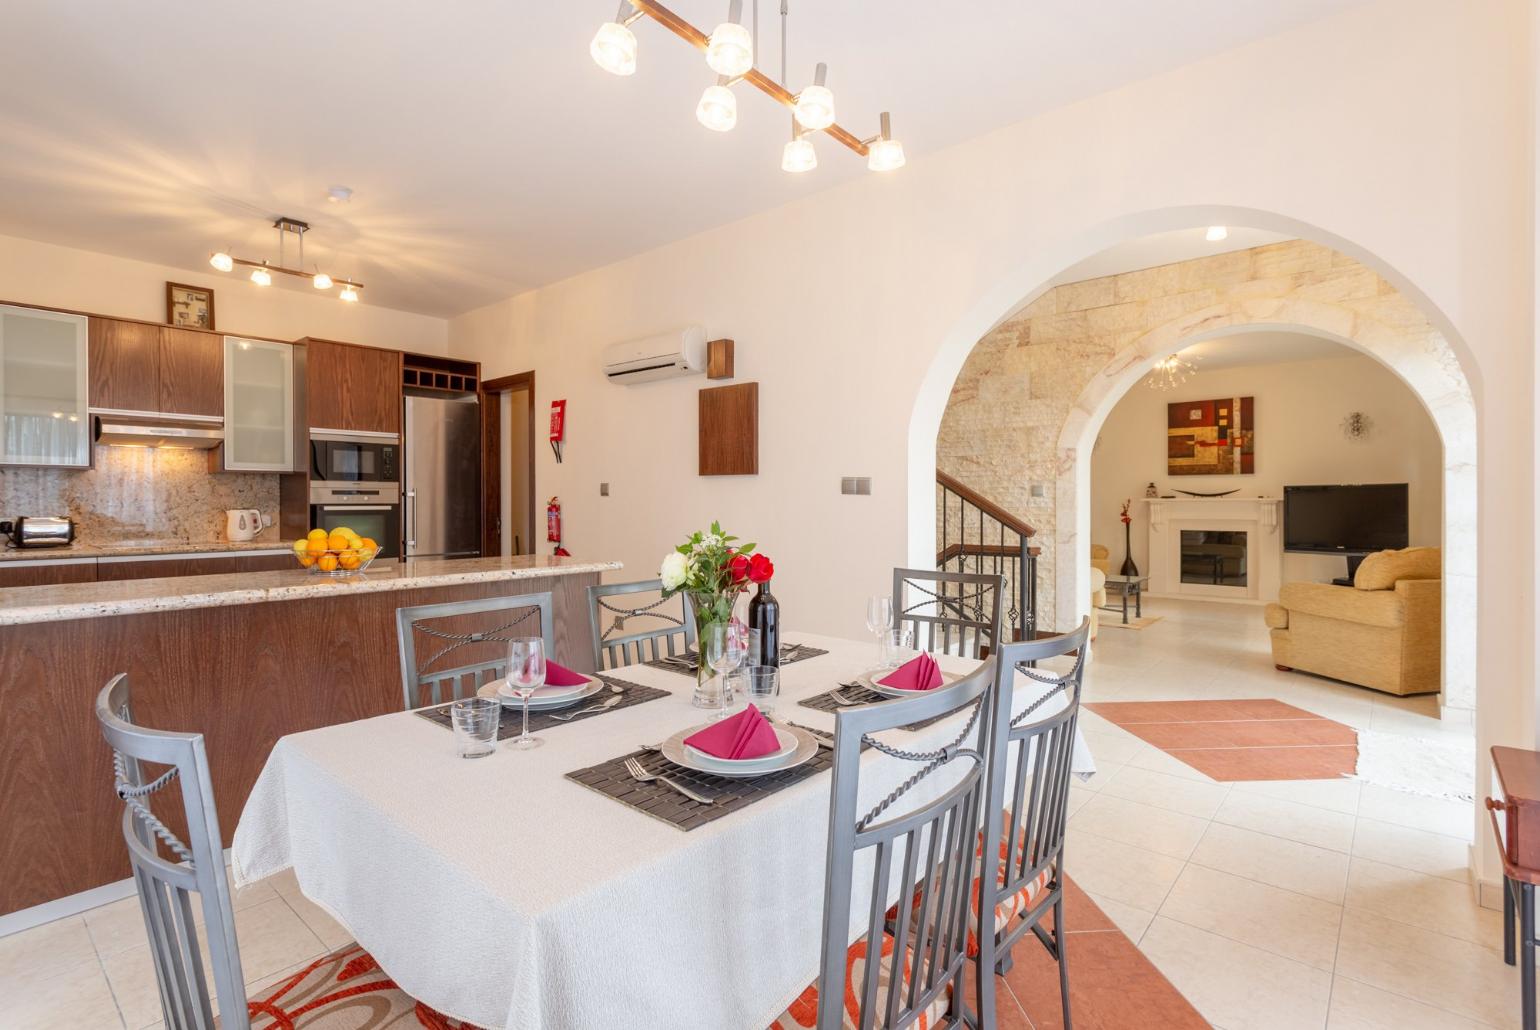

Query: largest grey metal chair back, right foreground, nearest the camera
left=818, top=664, right=995, bottom=1030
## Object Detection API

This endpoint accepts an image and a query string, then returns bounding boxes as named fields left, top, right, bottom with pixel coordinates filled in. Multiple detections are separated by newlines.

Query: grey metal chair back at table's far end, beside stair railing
left=893, top=568, right=1006, bottom=657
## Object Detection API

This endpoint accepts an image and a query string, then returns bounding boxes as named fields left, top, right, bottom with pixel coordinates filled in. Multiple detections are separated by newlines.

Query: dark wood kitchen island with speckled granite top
left=0, top=556, right=619, bottom=918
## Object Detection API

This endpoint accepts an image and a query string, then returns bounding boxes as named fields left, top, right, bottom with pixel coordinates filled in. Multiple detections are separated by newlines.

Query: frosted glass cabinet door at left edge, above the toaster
left=0, top=305, right=91, bottom=468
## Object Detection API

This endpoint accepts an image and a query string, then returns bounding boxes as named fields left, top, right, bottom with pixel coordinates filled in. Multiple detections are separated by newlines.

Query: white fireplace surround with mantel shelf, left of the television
left=1143, top=496, right=1283, bottom=602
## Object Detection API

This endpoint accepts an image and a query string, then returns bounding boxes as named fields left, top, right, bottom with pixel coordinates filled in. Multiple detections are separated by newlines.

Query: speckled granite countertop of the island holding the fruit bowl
left=0, top=554, right=621, bottom=625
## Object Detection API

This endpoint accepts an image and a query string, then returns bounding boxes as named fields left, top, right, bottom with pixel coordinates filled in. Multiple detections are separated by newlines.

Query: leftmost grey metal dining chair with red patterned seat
left=95, top=673, right=440, bottom=1030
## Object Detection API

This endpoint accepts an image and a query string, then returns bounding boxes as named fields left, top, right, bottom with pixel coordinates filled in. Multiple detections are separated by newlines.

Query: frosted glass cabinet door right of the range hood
left=225, top=336, right=294, bottom=473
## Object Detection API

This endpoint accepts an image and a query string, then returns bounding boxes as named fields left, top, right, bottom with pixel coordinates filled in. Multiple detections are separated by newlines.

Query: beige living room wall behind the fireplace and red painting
left=1090, top=348, right=1443, bottom=581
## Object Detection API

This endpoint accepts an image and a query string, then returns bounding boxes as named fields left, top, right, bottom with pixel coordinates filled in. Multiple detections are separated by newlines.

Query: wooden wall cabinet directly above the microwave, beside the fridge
left=300, top=339, right=400, bottom=433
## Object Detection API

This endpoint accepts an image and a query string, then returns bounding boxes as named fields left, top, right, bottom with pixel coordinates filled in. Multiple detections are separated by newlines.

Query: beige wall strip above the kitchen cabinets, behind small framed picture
left=0, top=236, right=448, bottom=354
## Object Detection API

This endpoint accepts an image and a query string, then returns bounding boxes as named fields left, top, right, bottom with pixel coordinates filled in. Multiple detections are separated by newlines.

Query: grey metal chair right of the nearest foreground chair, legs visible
left=975, top=619, right=1090, bottom=1030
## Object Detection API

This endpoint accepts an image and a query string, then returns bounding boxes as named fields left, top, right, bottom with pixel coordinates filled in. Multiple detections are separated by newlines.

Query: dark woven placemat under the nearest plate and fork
left=567, top=734, right=835, bottom=830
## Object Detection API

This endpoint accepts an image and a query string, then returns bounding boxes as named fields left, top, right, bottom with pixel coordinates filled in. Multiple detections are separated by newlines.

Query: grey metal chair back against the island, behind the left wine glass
left=396, top=590, right=556, bottom=711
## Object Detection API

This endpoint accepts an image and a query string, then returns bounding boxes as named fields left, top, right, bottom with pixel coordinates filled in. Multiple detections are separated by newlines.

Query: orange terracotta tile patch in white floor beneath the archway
left=1086, top=699, right=1358, bottom=781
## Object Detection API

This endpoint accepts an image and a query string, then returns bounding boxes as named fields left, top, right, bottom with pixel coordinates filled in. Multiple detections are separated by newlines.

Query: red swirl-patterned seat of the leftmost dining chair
left=246, top=944, right=480, bottom=1030
